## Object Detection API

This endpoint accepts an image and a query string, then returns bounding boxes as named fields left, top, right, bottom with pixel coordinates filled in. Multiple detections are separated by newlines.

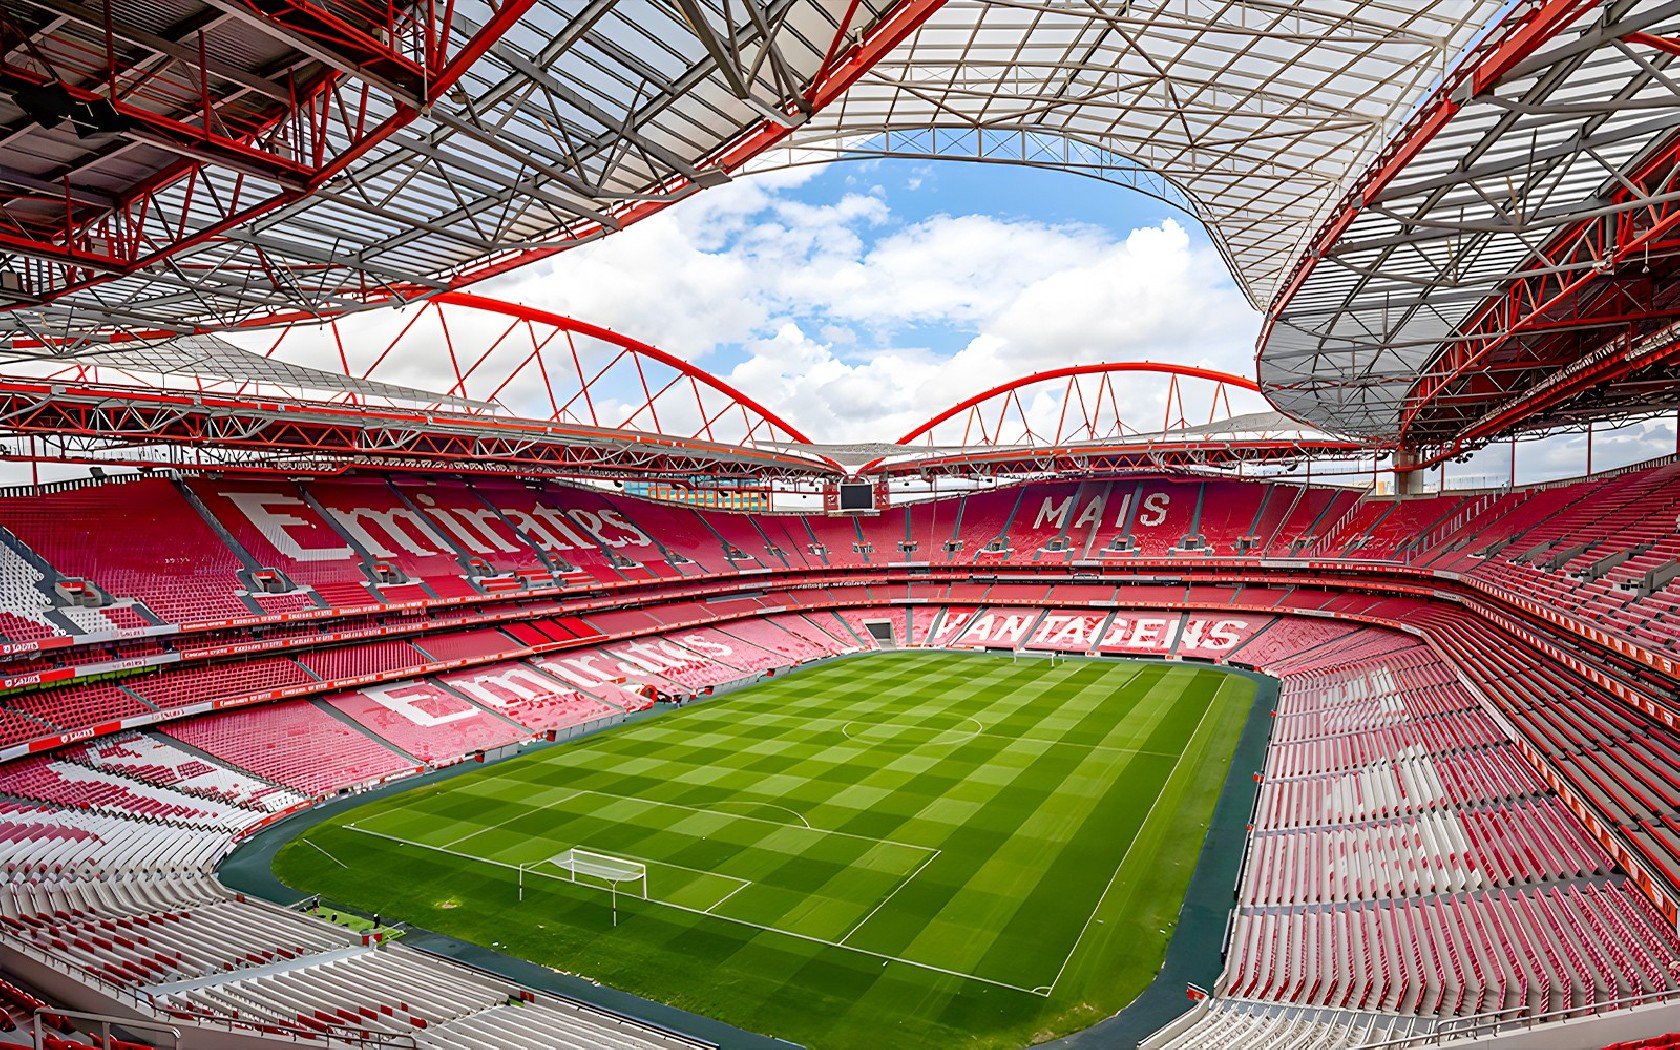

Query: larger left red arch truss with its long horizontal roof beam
left=0, top=292, right=842, bottom=477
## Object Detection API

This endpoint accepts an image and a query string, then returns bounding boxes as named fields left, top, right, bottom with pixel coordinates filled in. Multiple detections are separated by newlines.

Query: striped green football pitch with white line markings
left=274, top=652, right=1253, bottom=1050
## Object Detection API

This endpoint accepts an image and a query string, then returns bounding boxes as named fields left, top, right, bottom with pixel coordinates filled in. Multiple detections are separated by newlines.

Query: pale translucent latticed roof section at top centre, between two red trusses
left=764, top=0, right=1500, bottom=306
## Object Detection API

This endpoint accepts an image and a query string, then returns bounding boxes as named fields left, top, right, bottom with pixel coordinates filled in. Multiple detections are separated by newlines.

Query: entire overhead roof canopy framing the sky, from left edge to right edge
left=0, top=0, right=1680, bottom=470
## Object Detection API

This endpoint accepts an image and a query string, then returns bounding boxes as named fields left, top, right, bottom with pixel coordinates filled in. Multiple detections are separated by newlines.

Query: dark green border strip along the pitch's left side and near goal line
left=217, top=708, right=798, bottom=1050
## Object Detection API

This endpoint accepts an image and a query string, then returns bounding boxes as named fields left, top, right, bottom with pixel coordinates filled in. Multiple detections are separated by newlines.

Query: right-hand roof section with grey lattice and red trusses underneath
left=1258, top=0, right=1680, bottom=464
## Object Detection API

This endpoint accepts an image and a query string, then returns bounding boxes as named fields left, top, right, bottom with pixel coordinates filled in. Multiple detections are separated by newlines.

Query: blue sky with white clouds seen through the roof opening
left=467, top=160, right=1675, bottom=486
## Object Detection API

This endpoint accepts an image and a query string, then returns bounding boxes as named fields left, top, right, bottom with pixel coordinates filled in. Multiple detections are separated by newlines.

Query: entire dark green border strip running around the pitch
left=222, top=654, right=1277, bottom=1050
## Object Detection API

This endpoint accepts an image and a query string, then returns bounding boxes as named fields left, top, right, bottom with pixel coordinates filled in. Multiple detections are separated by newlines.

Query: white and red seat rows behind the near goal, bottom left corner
left=0, top=786, right=701, bottom=1050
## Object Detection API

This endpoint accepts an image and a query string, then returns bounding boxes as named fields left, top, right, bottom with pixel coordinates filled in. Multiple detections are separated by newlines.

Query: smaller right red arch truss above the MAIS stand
left=846, top=361, right=1361, bottom=475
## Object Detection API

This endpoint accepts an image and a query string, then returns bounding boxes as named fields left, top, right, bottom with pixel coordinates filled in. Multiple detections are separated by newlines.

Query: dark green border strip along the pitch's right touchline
left=1037, top=665, right=1278, bottom=1050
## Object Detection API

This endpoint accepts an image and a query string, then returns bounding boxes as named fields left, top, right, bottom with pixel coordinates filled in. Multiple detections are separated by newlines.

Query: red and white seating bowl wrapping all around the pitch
left=0, top=467, right=1680, bottom=1047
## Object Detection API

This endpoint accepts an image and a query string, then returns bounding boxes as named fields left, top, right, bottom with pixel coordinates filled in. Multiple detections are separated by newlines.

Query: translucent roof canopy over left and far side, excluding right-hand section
left=0, top=0, right=1497, bottom=348
